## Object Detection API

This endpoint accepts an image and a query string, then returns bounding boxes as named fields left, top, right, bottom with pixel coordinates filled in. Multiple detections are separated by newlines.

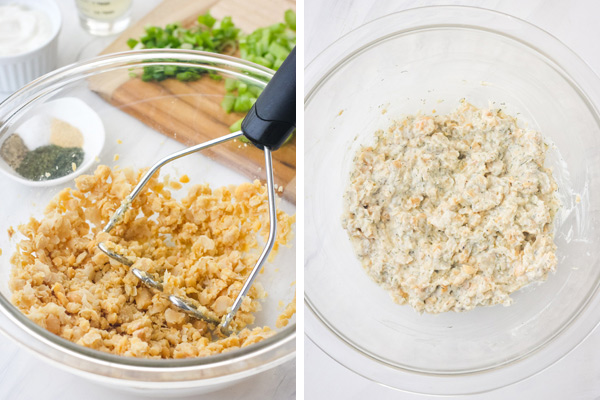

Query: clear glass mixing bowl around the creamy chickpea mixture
left=304, top=6, right=600, bottom=394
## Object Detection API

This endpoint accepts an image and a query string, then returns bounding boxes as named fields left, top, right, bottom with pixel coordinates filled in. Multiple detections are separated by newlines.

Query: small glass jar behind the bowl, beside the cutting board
left=75, top=0, right=132, bottom=36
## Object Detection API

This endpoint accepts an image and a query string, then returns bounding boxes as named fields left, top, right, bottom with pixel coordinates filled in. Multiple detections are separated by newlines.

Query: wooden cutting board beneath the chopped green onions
left=90, top=0, right=296, bottom=202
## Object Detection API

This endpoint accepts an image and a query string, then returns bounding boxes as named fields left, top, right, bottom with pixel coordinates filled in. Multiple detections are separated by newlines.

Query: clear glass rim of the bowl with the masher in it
left=0, top=49, right=296, bottom=384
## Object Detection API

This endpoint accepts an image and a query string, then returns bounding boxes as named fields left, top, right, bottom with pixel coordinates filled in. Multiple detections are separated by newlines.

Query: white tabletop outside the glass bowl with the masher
left=0, top=0, right=296, bottom=400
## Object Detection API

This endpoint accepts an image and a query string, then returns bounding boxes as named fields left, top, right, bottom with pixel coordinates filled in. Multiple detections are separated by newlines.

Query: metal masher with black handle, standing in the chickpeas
left=98, top=48, right=296, bottom=335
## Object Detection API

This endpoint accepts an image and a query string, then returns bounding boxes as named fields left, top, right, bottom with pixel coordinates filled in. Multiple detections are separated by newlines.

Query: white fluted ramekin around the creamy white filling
left=0, top=0, right=62, bottom=92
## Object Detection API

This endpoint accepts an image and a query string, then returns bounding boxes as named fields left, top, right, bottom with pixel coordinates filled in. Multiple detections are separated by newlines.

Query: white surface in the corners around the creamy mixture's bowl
left=304, top=0, right=600, bottom=400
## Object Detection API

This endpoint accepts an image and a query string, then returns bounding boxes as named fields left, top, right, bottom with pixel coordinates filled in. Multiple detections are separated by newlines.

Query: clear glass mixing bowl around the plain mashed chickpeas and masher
left=0, top=50, right=296, bottom=396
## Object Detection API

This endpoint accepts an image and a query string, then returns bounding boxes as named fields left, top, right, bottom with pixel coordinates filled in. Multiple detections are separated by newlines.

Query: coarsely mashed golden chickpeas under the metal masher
left=10, top=166, right=295, bottom=358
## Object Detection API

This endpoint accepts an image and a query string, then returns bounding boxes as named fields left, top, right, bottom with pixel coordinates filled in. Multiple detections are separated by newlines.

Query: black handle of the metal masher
left=242, top=47, right=296, bottom=150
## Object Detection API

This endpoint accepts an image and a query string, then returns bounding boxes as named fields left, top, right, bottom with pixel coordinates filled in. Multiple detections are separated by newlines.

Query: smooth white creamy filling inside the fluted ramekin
left=0, top=4, right=52, bottom=56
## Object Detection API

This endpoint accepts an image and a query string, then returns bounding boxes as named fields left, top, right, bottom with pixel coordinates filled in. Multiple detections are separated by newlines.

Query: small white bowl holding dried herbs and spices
left=0, top=97, right=105, bottom=186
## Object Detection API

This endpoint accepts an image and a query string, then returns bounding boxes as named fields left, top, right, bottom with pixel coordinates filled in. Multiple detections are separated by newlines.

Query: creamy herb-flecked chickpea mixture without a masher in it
left=342, top=101, right=560, bottom=313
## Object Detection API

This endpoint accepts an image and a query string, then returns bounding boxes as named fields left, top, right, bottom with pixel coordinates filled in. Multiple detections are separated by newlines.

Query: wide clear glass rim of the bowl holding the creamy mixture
left=304, top=6, right=600, bottom=395
